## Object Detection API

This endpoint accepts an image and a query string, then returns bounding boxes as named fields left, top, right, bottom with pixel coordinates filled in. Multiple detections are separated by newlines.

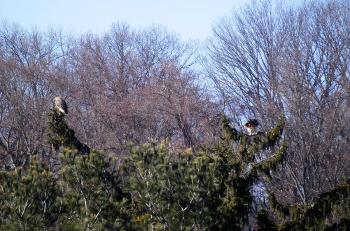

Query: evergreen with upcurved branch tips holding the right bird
left=205, top=113, right=286, bottom=230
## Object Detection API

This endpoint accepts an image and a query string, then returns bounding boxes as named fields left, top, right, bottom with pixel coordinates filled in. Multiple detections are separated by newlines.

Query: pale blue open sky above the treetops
left=0, top=0, right=249, bottom=40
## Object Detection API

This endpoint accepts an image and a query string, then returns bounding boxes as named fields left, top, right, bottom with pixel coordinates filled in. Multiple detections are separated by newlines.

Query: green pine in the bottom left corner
left=0, top=159, right=59, bottom=230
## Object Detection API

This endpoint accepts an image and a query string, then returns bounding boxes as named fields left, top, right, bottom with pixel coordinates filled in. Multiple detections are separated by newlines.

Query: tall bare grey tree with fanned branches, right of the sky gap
left=208, top=1, right=350, bottom=203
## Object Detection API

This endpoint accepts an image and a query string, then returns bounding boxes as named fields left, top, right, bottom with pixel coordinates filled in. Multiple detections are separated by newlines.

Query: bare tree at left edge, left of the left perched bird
left=0, top=24, right=68, bottom=166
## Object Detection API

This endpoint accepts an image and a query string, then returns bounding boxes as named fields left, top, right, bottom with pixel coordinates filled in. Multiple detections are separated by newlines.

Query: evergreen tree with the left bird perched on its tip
left=47, top=106, right=129, bottom=230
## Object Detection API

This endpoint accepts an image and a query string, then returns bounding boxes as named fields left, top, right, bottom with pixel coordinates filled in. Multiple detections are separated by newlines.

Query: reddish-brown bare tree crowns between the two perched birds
left=53, top=24, right=218, bottom=154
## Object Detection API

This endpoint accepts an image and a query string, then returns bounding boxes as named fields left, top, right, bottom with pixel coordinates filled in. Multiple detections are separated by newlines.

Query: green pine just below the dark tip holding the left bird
left=59, top=149, right=128, bottom=230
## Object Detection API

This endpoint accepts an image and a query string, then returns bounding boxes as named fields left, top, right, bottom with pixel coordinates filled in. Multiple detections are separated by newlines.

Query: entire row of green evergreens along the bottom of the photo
left=0, top=107, right=350, bottom=230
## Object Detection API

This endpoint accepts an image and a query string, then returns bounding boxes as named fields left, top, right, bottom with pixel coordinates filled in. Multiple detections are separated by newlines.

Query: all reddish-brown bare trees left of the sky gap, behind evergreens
left=0, top=24, right=218, bottom=166
